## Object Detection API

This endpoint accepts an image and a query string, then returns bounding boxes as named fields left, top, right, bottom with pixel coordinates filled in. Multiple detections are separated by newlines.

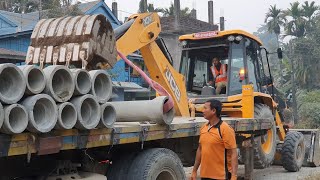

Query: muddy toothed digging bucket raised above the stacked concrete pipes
left=26, top=15, right=117, bottom=69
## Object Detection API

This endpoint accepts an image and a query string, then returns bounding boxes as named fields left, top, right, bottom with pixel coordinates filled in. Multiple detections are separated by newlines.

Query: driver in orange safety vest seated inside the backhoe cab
left=209, top=57, right=228, bottom=95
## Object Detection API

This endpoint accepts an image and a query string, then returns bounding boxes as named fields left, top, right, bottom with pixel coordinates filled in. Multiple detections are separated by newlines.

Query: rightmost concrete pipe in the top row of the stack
left=89, top=70, right=112, bottom=103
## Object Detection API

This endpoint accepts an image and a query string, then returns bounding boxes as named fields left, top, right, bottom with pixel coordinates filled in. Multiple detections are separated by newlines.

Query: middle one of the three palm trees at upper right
left=283, top=2, right=306, bottom=37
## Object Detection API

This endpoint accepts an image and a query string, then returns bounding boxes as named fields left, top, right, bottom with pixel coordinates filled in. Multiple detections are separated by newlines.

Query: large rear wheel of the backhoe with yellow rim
left=240, top=104, right=277, bottom=169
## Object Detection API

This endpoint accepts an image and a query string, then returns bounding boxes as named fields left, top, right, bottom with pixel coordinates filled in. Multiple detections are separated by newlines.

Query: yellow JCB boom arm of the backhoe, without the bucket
left=115, top=13, right=190, bottom=116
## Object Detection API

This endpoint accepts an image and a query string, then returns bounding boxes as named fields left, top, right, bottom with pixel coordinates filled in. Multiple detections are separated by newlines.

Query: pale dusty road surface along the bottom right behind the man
left=185, top=165, right=320, bottom=180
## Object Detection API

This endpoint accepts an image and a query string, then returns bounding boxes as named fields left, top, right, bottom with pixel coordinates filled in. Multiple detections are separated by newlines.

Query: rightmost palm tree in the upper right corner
left=302, top=1, right=319, bottom=31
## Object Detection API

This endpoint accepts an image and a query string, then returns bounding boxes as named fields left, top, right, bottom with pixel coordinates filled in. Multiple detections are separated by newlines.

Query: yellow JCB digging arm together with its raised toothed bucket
left=26, top=13, right=190, bottom=116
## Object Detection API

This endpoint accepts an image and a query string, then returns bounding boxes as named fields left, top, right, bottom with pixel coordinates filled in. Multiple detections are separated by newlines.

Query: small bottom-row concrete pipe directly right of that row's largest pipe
left=55, top=102, right=77, bottom=130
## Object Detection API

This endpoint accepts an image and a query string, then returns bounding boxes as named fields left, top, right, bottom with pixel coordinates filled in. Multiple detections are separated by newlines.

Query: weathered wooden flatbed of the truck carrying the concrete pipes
left=0, top=117, right=271, bottom=157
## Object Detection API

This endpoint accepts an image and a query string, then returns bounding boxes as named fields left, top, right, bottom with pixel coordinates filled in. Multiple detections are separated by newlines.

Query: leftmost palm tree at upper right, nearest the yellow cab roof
left=264, top=5, right=285, bottom=47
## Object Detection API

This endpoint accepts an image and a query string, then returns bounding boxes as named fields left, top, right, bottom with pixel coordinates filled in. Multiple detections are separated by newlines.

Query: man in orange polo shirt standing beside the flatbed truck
left=191, top=100, right=238, bottom=180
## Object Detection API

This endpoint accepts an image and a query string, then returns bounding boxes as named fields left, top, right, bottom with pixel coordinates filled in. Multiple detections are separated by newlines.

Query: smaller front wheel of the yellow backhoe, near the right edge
left=281, top=132, right=305, bottom=172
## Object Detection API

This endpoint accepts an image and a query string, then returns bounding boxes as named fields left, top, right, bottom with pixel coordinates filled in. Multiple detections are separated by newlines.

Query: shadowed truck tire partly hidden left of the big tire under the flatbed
left=106, top=153, right=137, bottom=180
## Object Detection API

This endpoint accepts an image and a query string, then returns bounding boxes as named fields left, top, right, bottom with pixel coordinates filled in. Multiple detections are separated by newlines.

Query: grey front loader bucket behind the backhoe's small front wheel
left=273, top=129, right=320, bottom=167
